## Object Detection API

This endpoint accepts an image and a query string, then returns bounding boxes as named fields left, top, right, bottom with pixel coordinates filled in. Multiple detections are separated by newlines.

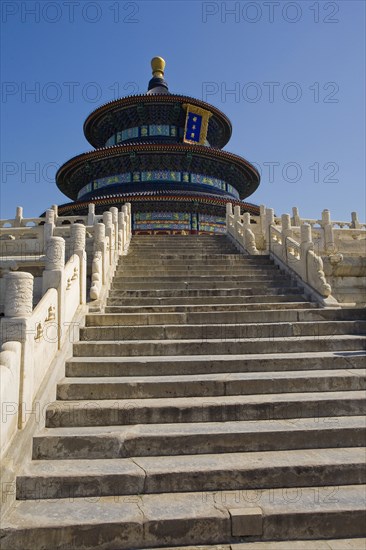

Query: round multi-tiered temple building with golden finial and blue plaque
left=56, top=57, right=260, bottom=234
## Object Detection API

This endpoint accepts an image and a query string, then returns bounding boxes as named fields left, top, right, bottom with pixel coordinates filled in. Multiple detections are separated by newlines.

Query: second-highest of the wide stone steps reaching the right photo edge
left=80, top=321, right=366, bottom=341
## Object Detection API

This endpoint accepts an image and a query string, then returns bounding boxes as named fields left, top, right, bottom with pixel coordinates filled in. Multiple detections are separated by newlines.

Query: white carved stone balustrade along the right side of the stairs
left=226, top=204, right=366, bottom=304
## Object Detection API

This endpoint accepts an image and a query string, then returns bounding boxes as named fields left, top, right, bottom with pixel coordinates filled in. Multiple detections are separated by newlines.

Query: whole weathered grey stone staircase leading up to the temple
left=2, top=236, right=366, bottom=550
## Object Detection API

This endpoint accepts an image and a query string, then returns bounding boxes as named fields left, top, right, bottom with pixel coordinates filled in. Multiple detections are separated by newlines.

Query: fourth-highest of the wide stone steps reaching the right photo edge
left=66, top=351, right=366, bottom=377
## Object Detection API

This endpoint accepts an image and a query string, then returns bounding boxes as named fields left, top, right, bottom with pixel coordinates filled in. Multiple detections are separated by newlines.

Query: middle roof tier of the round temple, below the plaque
left=56, top=143, right=260, bottom=200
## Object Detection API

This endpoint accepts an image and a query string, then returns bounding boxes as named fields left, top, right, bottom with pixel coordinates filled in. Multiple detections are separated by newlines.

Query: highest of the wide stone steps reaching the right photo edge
left=85, top=308, right=364, bottom=327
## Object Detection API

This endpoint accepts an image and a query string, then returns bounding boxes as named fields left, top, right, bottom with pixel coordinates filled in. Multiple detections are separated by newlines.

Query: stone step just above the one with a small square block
left=16, top=447, right=366, bottom=500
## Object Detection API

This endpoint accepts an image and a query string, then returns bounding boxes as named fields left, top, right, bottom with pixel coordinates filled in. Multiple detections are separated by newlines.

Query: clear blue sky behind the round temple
left=0, top=0, right=365, bottom=220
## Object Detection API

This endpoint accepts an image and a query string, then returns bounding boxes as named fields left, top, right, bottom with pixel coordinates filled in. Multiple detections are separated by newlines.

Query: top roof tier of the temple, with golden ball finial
left=84, top=57, right=232, bottom=149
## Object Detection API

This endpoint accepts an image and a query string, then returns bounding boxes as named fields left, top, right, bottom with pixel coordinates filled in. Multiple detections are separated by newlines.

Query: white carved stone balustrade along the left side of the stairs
left=0, top=204, right=131, bottom=462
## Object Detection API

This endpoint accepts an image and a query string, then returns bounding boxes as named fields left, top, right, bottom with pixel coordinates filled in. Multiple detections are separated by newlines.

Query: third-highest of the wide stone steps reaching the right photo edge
left=73, top=335, right=366, bottom=357
